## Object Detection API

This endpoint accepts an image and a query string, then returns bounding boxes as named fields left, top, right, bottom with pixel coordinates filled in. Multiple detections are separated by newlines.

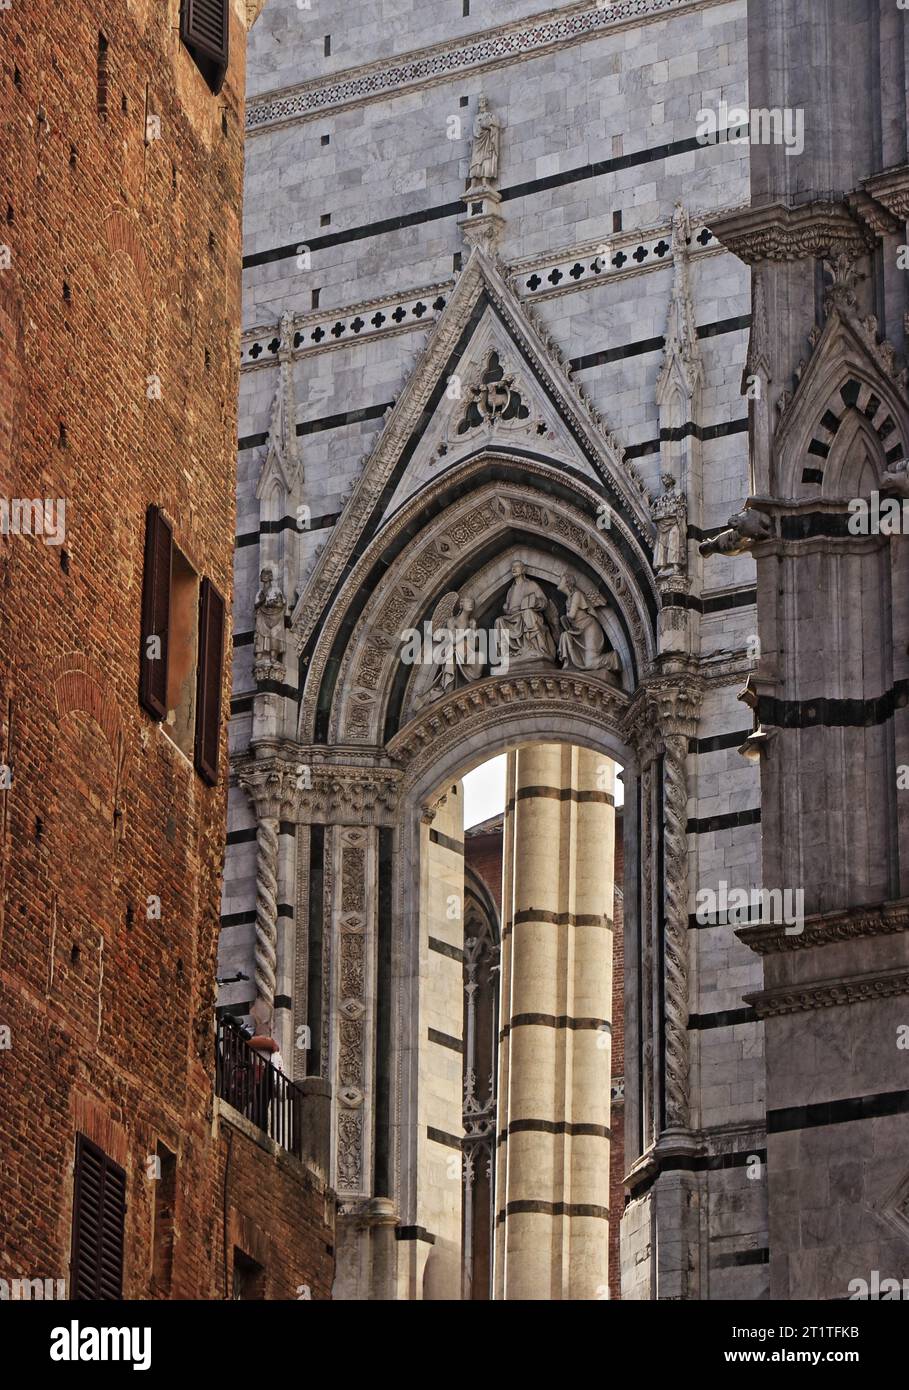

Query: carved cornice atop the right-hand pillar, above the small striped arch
left=710, top=202, right=874, bottom=265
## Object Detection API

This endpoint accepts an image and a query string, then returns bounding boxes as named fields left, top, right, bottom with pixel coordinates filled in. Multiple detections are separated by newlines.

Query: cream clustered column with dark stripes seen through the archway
left=496, top=744, right=614, bottom=1300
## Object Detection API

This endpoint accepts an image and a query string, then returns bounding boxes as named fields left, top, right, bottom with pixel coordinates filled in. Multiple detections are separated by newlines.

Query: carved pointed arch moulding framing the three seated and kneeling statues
left=299, top=448, right=656, bottom=745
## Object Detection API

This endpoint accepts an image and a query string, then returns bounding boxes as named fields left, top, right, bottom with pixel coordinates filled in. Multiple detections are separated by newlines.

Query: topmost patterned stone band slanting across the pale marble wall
left=246, top=0, right=721, bottom=133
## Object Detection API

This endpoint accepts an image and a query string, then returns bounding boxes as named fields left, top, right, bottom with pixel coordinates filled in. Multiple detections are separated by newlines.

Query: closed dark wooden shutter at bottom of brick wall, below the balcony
left=69, top=1134, right=126, bottom=1300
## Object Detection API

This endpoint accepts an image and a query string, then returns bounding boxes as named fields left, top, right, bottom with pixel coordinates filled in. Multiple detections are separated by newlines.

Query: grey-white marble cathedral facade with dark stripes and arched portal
left=220, top=0, right=909, bottom=1300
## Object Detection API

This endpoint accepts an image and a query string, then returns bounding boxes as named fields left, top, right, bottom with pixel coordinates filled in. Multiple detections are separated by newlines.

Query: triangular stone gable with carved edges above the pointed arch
left=293, top=247, right=652, bottom=637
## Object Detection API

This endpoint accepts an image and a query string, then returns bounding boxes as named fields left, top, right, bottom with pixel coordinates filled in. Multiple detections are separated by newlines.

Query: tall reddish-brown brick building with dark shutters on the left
left=0, top=0, right=332, bottom=1298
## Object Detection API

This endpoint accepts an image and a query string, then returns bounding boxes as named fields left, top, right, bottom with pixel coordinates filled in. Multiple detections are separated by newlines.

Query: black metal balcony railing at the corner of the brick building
left=215, top=1017, right=303, bottom=1159
